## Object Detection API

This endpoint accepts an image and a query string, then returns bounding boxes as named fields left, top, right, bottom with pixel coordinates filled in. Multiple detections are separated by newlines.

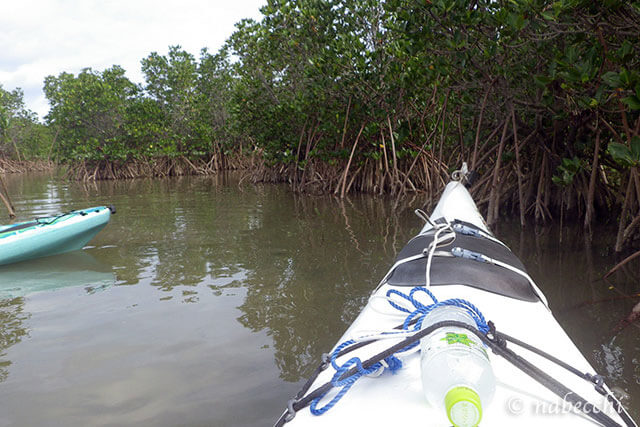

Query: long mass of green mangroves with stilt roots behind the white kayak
left=3, top=0, right=640, bottom=249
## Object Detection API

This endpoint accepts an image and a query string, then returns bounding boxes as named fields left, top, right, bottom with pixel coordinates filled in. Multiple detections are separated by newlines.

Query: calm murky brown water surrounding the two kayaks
left=0, top=172, right=640, bottom=426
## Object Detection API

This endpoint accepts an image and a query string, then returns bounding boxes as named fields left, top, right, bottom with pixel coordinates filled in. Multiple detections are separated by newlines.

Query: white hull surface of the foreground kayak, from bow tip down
left=276, top=182, right=626, bottom=427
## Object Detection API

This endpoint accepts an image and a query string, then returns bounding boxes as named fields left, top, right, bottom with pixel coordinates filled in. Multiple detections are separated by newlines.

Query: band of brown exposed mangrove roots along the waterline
left=0, top=154, right=640, bottom=252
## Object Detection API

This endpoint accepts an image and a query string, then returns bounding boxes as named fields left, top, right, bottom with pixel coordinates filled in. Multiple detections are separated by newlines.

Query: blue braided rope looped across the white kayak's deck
left=309, top=286, right=489, bottom=415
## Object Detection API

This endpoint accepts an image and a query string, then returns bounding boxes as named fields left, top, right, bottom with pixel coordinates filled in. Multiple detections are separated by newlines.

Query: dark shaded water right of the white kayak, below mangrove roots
left=498, top=219, right=640, bottom=416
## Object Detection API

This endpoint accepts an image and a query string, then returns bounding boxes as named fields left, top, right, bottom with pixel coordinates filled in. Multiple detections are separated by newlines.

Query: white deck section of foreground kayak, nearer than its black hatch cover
left=292, top=285, right=615, bottom=426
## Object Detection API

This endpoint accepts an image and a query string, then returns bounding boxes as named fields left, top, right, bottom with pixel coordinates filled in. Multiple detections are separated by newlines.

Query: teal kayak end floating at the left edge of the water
left=0, top=206, right=115, bottom=265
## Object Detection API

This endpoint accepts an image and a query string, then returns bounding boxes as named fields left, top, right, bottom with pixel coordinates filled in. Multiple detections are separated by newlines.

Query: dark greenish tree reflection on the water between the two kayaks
left=91, top=179, right=420, bottom=382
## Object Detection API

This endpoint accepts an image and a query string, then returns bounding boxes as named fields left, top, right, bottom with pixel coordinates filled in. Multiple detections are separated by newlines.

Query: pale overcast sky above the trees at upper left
left=0, top=0, right=266, bottom=118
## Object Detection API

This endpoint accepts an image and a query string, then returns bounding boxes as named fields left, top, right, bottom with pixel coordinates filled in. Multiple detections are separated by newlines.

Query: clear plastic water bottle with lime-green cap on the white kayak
left=420, top=306, right=496, bottom=427
